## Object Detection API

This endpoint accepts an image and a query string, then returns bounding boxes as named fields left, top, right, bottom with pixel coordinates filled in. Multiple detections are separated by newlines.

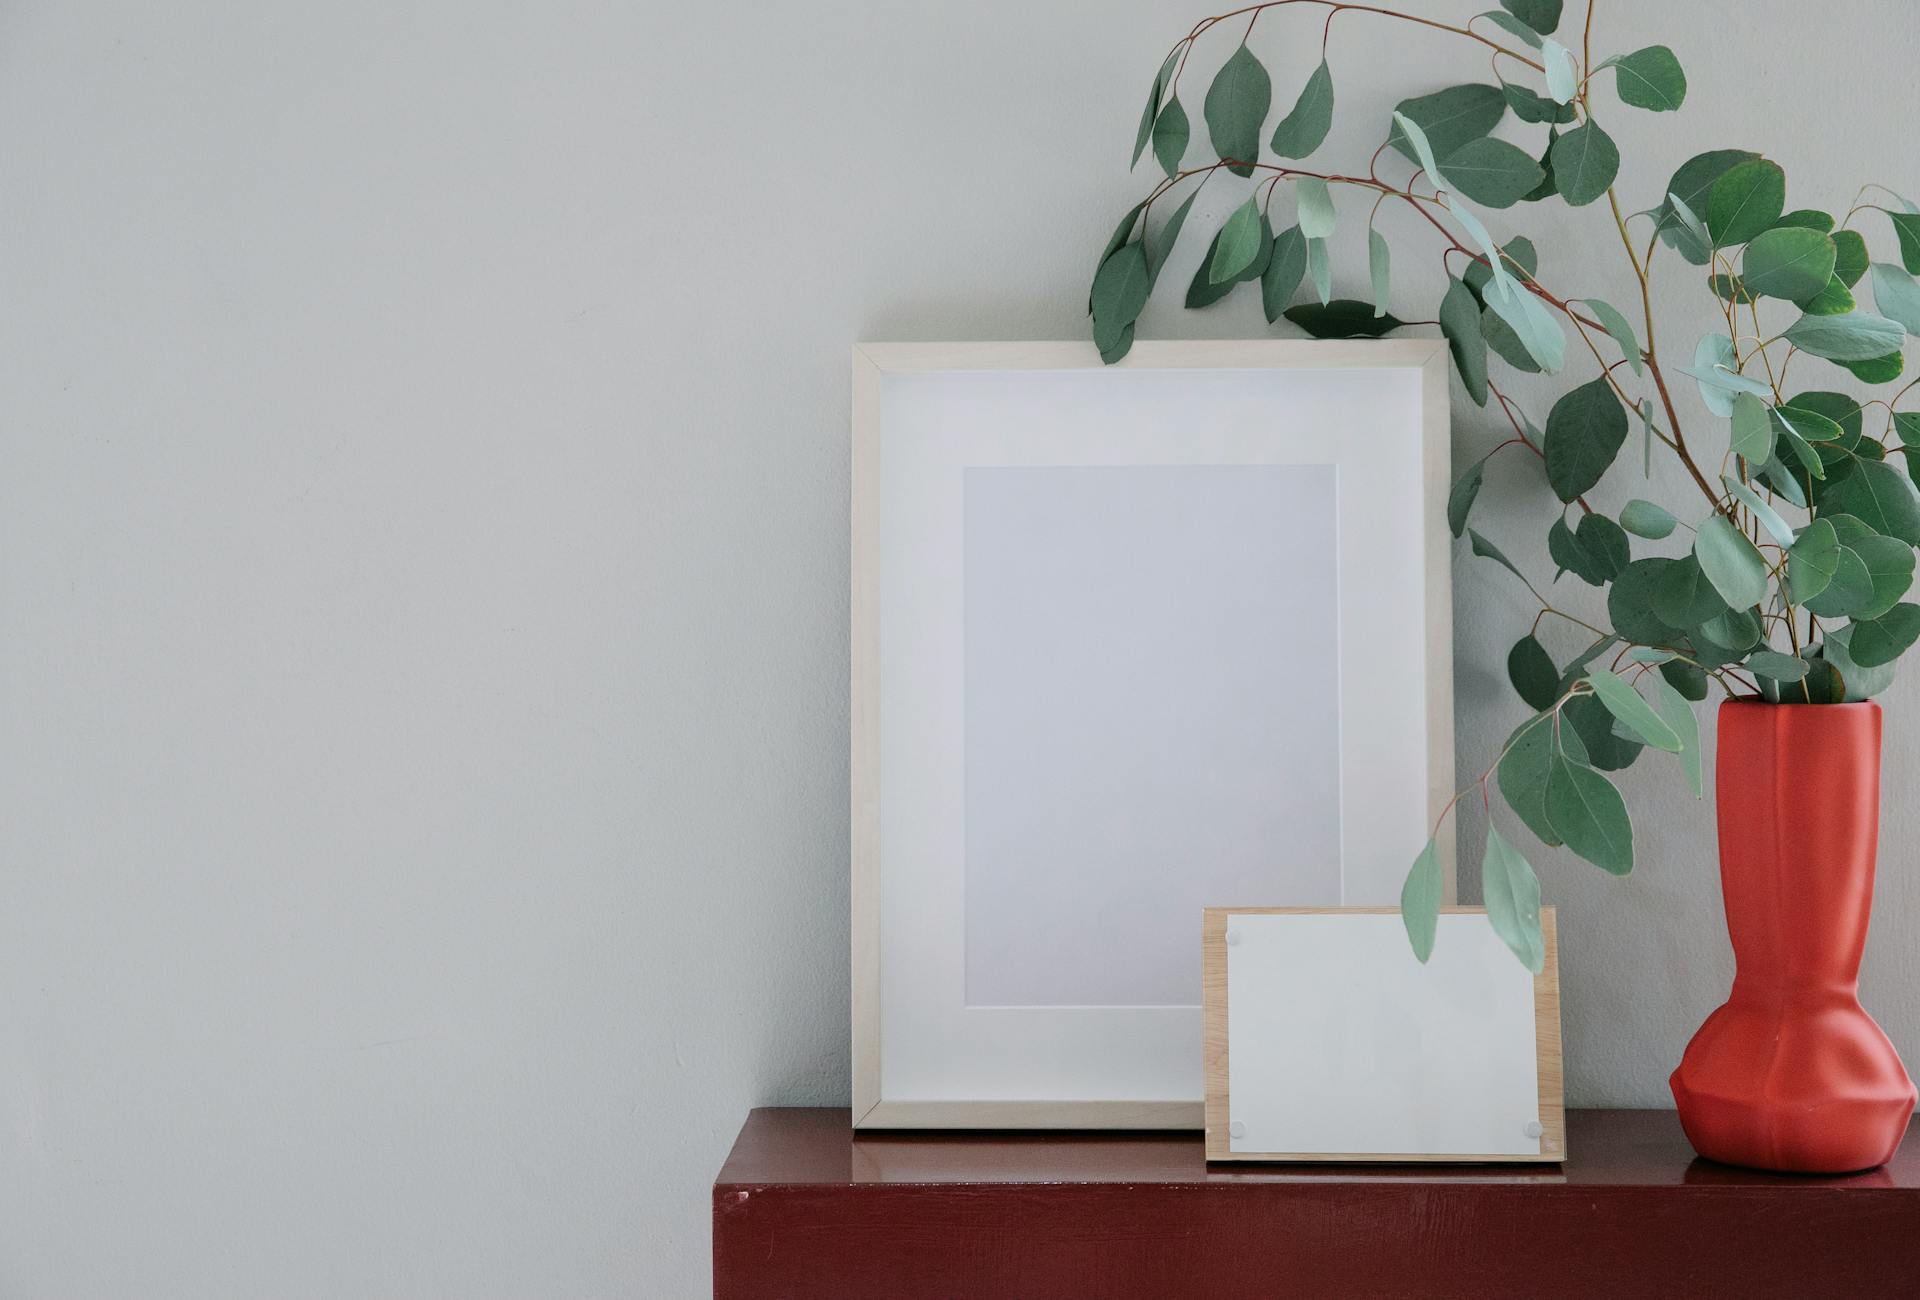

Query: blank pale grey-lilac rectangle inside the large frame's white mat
left=964, top=465, right=1342, bottom=1006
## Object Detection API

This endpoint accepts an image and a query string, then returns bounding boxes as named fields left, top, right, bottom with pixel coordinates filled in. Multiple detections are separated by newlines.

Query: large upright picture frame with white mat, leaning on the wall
left=851, top=340, right=1453, bottom=1129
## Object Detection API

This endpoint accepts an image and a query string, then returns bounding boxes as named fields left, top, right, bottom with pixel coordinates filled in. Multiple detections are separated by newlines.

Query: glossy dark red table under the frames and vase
left=714, top=1110, right=1920, bottom=1300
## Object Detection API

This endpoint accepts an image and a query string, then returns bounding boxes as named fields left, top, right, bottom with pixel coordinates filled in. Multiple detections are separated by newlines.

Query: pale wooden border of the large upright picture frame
left=851, top=338, right=1455, bottom=1129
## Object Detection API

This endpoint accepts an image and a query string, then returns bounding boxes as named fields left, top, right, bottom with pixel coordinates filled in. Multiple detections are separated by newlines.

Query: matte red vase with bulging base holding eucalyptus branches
left=1668, top=701, right=1914, bottom=1173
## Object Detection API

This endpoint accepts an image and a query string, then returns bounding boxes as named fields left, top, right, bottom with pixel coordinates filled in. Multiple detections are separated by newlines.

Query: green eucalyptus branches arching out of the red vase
left=1089, top=0, right=1920, bottom=970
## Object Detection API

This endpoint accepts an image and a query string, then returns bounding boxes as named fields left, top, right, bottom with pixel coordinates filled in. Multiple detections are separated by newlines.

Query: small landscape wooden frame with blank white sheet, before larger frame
left=1202, top=908, right=1567, bottom=1164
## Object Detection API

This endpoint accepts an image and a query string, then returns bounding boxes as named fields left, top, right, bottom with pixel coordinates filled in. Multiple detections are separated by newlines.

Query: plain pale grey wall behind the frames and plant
left=0, top=0, right=1920, bottom=1300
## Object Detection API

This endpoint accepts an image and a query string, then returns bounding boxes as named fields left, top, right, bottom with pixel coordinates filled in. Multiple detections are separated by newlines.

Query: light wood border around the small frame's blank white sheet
left=1200, top=906, right=1567, bottom=1164
